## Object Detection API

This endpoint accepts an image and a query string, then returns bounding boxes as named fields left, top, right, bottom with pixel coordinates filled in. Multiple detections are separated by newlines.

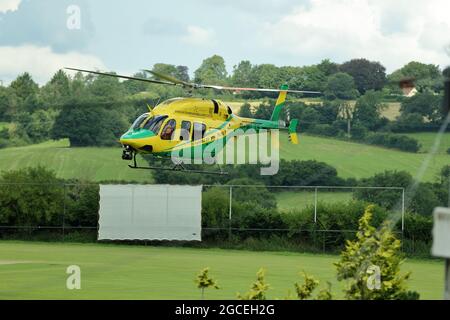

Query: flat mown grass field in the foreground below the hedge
left=0, top=241, right=444, bottom=299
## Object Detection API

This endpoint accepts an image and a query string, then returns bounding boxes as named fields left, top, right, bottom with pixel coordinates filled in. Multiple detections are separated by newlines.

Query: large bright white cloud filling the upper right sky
left=261, top=0, right=450, bottom=71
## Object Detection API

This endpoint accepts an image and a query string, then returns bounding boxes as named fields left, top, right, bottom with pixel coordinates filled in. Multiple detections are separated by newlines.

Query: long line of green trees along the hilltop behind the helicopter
left=0, top=55, right=443, bottom=151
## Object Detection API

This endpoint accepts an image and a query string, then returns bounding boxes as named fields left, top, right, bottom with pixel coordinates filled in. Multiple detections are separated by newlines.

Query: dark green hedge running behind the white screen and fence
left=0, top=167, right=442, bottom=254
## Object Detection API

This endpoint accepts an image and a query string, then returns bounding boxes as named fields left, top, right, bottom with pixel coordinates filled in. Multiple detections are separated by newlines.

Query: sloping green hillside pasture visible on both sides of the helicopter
left=0, top=134, right=450, bottom=182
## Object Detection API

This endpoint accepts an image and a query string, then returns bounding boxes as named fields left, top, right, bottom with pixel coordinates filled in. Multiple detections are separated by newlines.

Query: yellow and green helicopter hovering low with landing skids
left=65, top=67, right=320, bottom=174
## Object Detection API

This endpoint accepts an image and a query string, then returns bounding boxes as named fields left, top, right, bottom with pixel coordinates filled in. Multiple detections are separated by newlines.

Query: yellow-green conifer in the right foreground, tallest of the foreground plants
left=335, top=206, right=419, bottom=300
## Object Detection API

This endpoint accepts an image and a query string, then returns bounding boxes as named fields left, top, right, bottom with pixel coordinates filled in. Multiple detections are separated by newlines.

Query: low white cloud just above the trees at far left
left=0, top=45, right=105, bottom=84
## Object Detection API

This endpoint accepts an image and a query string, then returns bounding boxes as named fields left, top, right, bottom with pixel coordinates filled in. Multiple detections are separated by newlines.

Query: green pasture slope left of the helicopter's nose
left=0, top=140, right=153, bottom=182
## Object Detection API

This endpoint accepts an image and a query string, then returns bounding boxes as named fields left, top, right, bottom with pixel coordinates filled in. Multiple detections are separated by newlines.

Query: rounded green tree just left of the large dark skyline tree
left=324, top=72, right=358, bottom=100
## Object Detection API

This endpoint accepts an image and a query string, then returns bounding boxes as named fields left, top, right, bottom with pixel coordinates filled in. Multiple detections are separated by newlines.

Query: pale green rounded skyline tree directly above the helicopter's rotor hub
left=194, top=55, right=227, bottom=84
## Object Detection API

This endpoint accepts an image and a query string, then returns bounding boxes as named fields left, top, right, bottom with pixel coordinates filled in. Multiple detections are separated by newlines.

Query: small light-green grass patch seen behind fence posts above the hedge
left=275, top=190, right=353, bottom=210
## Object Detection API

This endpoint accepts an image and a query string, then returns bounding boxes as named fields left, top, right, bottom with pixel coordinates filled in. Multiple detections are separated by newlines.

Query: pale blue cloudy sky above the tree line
left=0, top=0, right=450, bottom=84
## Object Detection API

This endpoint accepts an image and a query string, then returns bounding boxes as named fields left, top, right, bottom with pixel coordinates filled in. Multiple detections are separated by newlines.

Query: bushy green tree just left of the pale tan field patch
left=353, top=90, right=387, bottom=130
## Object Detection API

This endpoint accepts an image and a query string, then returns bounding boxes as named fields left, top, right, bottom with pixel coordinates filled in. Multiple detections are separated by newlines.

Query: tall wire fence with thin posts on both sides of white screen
left=0, top=183, right=431, bottom=253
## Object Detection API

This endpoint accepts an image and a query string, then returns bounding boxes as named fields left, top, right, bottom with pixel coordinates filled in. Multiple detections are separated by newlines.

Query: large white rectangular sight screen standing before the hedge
left=98, top=185, right=202, bottom=241
